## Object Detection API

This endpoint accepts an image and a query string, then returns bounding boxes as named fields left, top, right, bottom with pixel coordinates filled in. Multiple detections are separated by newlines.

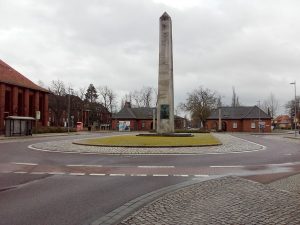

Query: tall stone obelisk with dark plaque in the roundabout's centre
left=157, top=12, right=174, bottom=134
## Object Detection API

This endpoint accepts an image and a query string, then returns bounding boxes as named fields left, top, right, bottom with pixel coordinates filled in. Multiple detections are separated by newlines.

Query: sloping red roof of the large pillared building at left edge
left=0, top=59, right=48, bottom=92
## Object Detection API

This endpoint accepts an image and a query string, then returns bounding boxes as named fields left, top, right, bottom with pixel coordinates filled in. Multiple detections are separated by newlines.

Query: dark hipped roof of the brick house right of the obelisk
left=208, top=106, right=271, bottom=119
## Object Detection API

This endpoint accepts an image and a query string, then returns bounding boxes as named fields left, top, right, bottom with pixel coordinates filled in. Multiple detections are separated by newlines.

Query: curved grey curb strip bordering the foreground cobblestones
left=90, top=175, right=222, bottom=225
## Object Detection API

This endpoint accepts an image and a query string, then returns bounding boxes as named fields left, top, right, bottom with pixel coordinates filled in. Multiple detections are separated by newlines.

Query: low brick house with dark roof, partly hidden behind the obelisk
left=112, top=102, right=186, bottom=131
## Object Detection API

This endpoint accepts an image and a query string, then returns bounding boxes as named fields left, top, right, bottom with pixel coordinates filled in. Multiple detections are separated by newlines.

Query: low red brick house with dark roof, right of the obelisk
left=207, top=106, right=272, bottom=132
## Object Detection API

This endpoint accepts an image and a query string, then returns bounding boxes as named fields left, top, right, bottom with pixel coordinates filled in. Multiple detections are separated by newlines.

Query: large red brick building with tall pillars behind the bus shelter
left=0, top=60, right=49, bottom=133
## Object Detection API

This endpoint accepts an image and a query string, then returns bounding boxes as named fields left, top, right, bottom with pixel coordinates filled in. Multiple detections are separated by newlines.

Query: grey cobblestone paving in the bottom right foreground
left=119, top=177, right=300, bottom=225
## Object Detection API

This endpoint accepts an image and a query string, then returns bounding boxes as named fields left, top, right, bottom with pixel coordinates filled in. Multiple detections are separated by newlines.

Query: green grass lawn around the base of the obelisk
left=80, top=133, right=221, bottom=147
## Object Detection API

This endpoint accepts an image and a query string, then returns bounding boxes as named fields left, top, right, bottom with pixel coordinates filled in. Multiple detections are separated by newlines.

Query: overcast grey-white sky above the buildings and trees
left=0, top=0, right=300, bottom=115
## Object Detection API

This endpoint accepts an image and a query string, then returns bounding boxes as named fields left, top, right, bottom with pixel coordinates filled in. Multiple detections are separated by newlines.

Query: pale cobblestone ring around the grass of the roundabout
left=32, top=133, right=262, bottom=154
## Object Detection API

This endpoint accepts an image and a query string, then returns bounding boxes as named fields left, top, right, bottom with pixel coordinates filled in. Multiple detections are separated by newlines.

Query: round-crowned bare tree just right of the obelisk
left=181, top=87, right=217, bottom=126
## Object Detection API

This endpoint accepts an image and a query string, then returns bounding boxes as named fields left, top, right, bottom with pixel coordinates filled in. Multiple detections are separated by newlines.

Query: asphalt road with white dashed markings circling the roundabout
left=0, top=134, right=300, bottom=225
